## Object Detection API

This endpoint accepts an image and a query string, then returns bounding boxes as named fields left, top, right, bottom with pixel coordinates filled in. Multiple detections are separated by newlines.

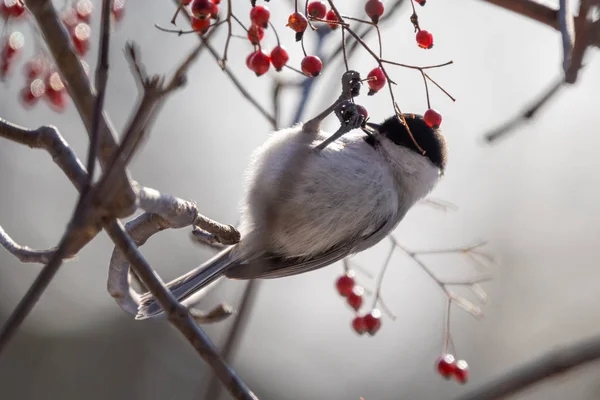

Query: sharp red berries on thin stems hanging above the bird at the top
left=159, top=0, right=454, bottom=133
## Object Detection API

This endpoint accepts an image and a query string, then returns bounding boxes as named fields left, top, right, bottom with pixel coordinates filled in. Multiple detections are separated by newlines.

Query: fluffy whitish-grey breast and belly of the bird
left=242, top=127, right=398, bottom=257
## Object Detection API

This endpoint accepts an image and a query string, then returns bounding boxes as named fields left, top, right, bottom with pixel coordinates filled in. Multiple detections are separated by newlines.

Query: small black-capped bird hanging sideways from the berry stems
left=136, top=76, right=446, bottom=319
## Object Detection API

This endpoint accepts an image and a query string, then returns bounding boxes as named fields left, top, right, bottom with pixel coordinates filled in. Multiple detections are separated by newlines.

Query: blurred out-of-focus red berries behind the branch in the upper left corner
left=0, top=0, right=125, bottom=112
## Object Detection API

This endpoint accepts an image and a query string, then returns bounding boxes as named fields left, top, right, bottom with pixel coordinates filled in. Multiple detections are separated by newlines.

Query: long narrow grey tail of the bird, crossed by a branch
left=135, top=246, right=234, bottom=319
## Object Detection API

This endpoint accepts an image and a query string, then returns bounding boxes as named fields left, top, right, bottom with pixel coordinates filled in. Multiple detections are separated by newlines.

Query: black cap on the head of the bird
left=367, top=114, right=446, bottom=171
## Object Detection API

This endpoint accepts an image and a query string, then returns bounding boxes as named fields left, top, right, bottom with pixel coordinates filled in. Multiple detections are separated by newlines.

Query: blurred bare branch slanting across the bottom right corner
left=455, top=336, right=600, bottom=400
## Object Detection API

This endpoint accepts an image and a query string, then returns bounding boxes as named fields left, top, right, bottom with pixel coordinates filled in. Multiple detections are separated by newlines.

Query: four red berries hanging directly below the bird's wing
left=335, top=270, right=381, bottom=336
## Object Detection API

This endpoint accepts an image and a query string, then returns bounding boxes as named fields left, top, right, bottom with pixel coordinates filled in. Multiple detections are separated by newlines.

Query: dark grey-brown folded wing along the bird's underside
left=225, top=216, right=401, bottom=279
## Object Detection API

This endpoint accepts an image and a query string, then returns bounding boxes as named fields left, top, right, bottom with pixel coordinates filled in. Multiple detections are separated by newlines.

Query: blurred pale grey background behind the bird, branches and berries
left=0, top=0, right=600, bottom=400
